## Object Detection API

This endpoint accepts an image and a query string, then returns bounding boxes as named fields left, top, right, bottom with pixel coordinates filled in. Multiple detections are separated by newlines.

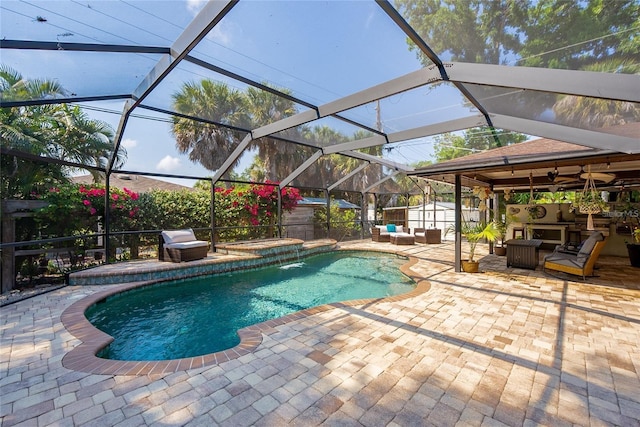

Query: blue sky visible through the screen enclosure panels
left=0, top=0, right=482, bottom=186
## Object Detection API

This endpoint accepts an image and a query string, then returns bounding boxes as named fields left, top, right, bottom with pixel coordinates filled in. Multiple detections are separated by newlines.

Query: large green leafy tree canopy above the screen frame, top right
left=395, top=0, right=640, bottom=70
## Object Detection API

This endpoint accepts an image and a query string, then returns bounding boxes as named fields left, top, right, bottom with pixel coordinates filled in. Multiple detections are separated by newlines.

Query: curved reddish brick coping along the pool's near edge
left=60, top=248, right=431, bottom=376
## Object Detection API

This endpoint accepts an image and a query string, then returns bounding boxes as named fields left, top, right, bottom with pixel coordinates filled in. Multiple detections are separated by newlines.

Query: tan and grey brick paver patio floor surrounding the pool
left=0, top=241, right=640, bottom=426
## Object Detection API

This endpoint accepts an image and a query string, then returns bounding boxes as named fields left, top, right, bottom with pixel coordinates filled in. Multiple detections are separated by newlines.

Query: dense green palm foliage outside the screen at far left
left=0, top=66, right=126, bottom=198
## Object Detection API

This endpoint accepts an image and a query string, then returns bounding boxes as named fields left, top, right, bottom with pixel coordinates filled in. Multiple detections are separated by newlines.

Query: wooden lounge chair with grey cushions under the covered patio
left=543, top=231, right=606, bottom=280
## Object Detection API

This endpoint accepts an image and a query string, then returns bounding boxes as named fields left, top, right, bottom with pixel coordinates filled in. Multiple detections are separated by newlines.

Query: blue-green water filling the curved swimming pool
left=86, top=252, right=415, bottom=360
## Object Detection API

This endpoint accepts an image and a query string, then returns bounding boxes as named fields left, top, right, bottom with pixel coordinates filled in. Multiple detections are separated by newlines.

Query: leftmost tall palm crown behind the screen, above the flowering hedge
left=172, top=80, right=250, bottom=171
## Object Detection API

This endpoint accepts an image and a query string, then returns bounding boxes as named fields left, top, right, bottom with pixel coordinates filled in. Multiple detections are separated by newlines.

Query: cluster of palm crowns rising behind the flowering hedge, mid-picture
left=172, top=80, right=382, bottom=187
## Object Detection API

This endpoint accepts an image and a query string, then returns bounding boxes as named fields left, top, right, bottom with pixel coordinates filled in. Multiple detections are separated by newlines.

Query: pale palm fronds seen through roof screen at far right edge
left=553, top=59, right=640, bottom=129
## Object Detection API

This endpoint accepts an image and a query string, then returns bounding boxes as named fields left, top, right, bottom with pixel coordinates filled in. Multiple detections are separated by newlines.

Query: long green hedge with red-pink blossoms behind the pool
left=33, top=182, right=302, bottom=257
